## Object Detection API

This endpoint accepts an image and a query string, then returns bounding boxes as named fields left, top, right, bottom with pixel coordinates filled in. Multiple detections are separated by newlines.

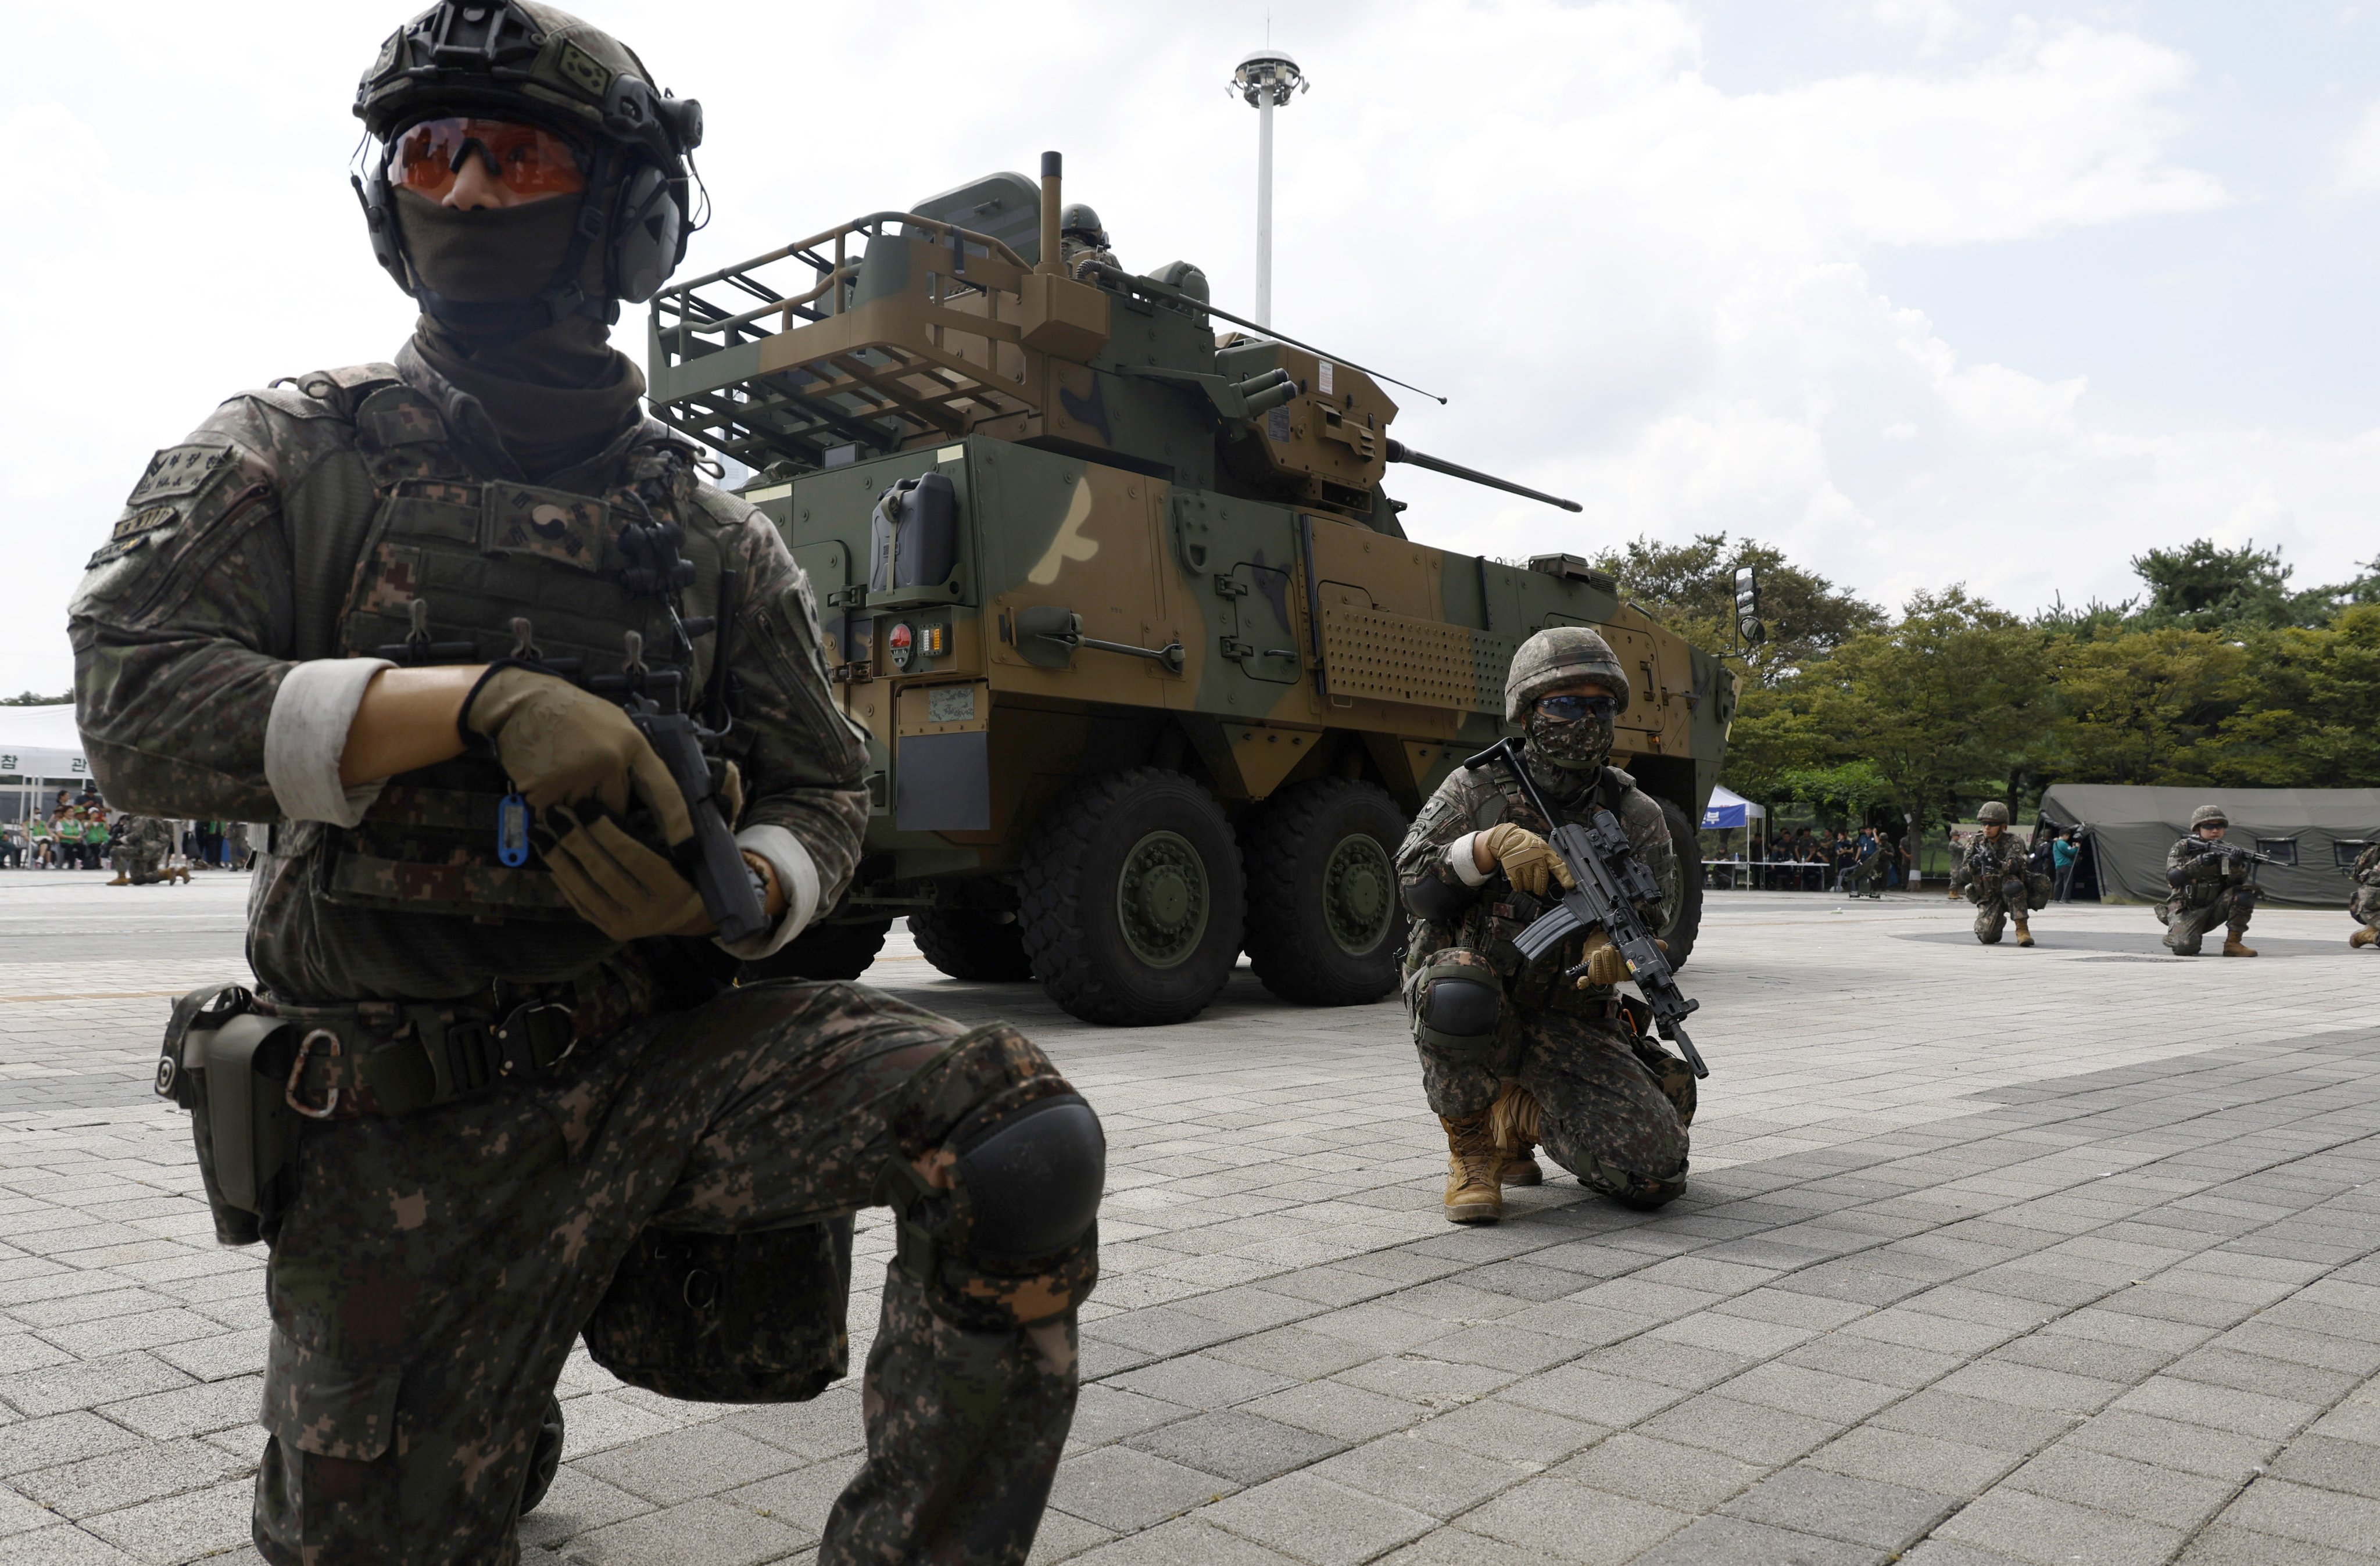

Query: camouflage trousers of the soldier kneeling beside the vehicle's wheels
left=1421, top=1009, right=1695, bottom=1207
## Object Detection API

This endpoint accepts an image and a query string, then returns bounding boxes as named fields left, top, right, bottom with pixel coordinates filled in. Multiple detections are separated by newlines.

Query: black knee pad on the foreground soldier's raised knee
left=883, top=1026, right=1107, bottom=1333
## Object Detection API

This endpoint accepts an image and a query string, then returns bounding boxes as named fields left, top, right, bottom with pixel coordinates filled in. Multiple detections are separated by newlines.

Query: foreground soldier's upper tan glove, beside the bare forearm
left=457, top=666, right=695, bottom=842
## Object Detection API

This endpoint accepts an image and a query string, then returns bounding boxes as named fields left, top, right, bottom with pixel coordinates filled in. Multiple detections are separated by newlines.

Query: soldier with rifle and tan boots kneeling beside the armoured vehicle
left=1397, top=626, right=1695, bottom=1223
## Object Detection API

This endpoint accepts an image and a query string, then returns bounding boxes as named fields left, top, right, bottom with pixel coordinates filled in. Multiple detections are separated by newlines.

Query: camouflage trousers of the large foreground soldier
left=255, top=986, right=1095, bottom=1566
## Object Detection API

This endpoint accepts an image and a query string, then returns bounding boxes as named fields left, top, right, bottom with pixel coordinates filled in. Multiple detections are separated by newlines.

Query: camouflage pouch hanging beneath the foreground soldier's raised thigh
left=583, top=1214, right=852, bottom=1402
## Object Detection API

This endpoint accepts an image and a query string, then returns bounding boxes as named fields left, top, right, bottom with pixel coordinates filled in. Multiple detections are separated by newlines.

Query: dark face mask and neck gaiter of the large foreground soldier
left=398, top=191, right=645, bottom=481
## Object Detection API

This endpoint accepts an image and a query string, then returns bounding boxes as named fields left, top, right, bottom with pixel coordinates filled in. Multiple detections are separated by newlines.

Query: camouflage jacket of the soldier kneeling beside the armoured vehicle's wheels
left=1397, top=766, right=1680, bottom=1007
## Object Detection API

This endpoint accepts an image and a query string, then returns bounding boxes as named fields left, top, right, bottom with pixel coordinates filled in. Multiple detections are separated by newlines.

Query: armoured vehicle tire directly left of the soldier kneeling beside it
left=1240, top=778, right=1411, bottom=1007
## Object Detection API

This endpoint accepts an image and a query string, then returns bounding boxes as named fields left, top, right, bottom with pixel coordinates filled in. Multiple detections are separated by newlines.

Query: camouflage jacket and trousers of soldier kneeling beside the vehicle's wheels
left=1397, top=766, right=1695, bottom=1204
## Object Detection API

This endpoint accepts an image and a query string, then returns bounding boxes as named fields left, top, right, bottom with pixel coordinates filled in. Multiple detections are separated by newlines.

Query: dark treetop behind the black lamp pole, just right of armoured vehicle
left=1590, top=533, right=1885, bottom=686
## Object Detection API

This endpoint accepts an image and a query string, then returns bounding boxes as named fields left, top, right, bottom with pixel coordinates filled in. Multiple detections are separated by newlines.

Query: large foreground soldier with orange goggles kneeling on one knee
left=69, top=0, right=1104, bottom=1566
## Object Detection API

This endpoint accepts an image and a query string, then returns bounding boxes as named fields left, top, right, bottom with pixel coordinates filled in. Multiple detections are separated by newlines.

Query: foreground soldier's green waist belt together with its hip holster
left=155, top=971, right=657, bottom=1245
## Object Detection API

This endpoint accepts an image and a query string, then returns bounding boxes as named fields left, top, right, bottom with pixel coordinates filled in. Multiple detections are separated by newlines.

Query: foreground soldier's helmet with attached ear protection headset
left=355, top=0, right=702, bottom=333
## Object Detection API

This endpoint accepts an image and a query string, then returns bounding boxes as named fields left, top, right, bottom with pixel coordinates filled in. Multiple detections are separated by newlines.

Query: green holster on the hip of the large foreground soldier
left=155, top=986, right=298, bottom=1245
